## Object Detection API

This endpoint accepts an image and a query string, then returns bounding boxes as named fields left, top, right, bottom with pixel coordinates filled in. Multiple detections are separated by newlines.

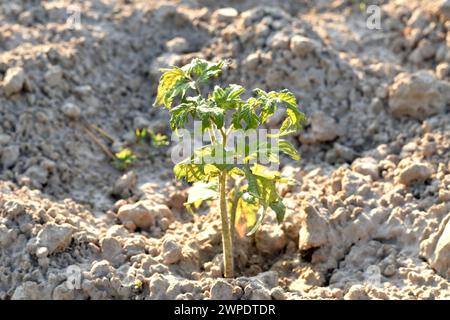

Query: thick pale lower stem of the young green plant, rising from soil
left=219, top=172, right=234, bottom=278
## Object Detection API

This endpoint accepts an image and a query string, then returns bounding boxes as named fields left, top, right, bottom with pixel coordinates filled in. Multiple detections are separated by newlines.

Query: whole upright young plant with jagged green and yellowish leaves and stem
left=154, top=59, right=305, bottom=278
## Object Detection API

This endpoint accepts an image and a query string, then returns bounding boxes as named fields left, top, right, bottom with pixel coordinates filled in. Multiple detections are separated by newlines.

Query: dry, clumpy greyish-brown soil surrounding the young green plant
left=0, top=0, right=450, bottom=300
